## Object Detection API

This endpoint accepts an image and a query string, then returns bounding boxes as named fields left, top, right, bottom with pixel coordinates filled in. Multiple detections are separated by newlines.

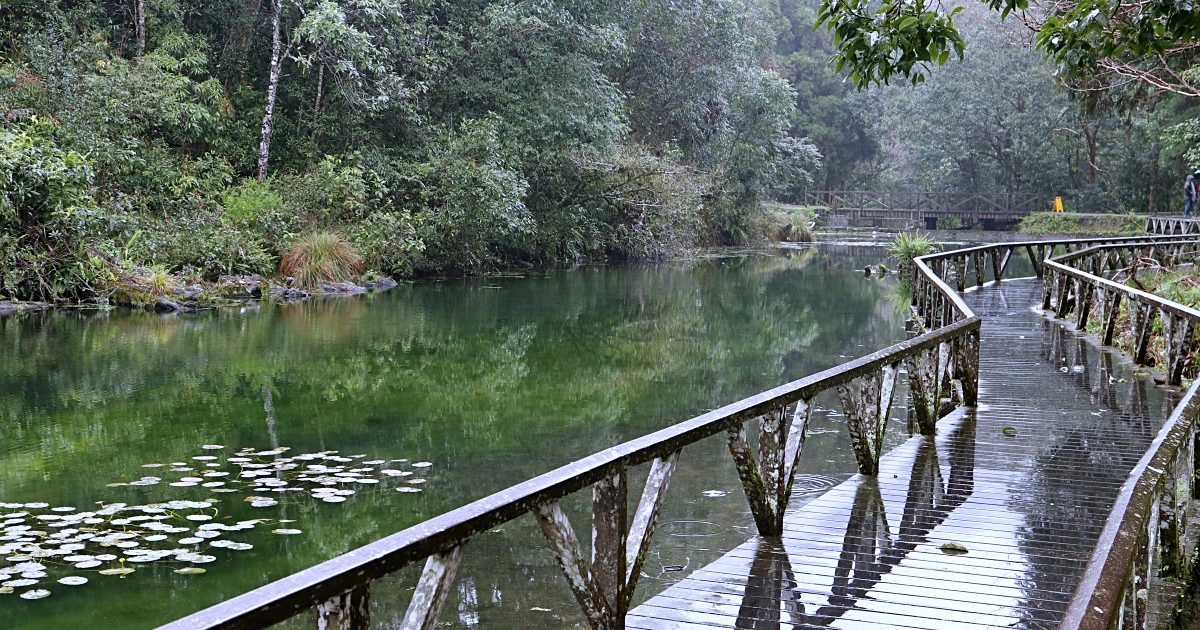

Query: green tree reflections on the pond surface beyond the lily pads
left=0, top=248, right=899, bottom=475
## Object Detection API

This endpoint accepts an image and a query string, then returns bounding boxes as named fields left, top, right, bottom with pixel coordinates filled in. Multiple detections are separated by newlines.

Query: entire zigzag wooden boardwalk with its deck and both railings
left=167, top=223, right=1200, bottom=630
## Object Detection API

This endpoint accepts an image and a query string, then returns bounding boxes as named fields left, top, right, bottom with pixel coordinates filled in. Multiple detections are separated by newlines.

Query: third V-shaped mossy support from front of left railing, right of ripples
left=838, top=364, right=900, bottom=475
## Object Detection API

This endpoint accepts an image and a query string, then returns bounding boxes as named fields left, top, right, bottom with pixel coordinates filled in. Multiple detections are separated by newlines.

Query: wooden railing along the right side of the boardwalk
left=1044, top=235, right=1200, bottom=630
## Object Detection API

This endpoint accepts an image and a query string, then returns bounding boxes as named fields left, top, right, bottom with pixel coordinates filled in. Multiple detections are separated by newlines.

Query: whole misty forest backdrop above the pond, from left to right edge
left=0, top=0, right=1200, bottom=302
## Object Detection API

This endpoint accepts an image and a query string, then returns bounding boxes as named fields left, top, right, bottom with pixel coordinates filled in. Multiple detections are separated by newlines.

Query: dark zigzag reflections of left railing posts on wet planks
left=736, top=416, right=976, bottom=630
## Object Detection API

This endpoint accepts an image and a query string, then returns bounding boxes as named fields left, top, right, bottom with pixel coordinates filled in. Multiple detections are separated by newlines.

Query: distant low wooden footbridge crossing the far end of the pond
left=804, top=191, right=1054, bottom=229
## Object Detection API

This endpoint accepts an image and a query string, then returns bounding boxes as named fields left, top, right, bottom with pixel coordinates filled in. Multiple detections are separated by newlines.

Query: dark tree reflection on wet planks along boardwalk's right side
left=1009, top=322, right=1170, bottom=628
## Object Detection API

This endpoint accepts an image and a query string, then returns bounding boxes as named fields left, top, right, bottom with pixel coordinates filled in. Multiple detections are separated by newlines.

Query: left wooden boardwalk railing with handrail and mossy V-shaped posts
left=166, top=230, right=1195, bottom=629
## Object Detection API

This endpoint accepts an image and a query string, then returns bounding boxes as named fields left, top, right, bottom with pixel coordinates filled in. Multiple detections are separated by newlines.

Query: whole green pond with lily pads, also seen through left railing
left=0, top=244, right=904, bottom=629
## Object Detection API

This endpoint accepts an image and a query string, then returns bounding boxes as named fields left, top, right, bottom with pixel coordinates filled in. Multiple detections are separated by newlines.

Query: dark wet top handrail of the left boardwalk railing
left=164, top=230, right=1177, bottom=630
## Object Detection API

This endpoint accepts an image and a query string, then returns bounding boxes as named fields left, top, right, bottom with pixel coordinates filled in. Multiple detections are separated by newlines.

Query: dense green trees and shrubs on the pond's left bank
left=0, top=0, right=820, bottom=299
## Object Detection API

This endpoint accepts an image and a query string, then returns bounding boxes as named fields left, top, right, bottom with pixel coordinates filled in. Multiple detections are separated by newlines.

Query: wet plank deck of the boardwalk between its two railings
left=626, top=280, right=1176, bottom=629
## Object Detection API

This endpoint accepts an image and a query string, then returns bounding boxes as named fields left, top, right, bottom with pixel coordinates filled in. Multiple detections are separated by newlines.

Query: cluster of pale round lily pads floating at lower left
left=0, top=444, right=432, bottom=600
